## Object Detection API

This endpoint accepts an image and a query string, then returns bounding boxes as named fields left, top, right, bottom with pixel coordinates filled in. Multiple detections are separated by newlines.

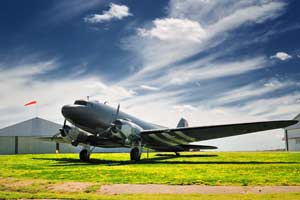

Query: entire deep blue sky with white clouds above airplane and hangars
left=0, top=0, right=300, bottom=150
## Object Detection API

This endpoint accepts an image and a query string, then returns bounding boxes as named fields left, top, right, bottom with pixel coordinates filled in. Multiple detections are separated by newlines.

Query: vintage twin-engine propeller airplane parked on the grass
left=51, top=100, right=300, bottom=161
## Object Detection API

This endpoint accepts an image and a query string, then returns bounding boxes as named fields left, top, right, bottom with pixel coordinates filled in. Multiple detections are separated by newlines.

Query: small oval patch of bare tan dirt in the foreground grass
left=48, top=182, right=93, bottom=192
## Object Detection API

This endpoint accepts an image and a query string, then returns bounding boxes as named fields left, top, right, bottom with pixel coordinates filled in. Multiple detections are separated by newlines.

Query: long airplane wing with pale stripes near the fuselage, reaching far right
left=141, top=120, right=298, bottom=149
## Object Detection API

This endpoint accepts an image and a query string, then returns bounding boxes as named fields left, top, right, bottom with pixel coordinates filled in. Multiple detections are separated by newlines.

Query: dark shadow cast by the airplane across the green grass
left=32, top=154, right=300, bottom=167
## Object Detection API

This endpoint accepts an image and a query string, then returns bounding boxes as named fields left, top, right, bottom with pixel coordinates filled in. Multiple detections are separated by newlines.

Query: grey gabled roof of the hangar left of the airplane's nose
left=0, top=117, right=62, bottom=137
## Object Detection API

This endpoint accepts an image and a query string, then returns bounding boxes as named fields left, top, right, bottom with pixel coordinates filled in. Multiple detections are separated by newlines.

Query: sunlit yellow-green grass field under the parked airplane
left=0, top=152, right=300, bottom=199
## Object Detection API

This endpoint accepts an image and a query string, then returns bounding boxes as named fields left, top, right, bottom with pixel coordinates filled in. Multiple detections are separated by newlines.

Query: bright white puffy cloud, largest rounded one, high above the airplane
left=138, top=18, right=206, bottom=42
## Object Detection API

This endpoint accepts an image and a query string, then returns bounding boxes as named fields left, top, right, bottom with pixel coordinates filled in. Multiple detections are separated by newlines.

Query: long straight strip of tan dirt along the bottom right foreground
left=98, top=184, right=300, bottom=195
